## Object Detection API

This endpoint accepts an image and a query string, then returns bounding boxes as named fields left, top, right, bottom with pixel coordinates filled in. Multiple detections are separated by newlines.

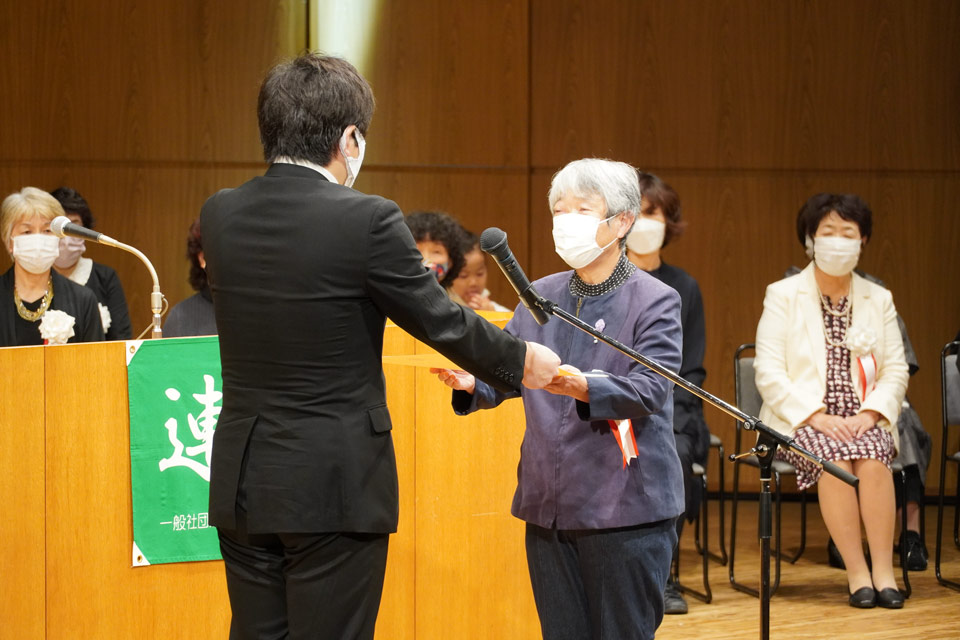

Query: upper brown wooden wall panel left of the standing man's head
left=6, top=0, right=304, bottom=165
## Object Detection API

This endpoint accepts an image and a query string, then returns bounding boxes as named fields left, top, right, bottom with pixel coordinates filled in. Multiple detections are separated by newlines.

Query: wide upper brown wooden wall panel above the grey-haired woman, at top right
left=530, top=0, right=960, bottom=171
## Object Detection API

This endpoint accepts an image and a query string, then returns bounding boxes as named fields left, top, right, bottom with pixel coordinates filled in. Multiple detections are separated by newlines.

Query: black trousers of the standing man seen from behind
left=217, top=510, right=389, bottom=640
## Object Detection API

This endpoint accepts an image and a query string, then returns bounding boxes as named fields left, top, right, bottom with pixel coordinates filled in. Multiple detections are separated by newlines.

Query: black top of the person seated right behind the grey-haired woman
left=647, top=262, right=710, bottom=463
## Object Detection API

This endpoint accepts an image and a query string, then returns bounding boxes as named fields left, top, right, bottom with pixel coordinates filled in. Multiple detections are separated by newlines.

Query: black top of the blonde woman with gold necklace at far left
left=0, top=267, right=103, bottom=347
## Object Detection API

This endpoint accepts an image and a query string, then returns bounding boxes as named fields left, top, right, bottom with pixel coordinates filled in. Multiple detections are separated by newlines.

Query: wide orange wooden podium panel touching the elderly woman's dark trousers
left=408, top=323, right=540, bottom=640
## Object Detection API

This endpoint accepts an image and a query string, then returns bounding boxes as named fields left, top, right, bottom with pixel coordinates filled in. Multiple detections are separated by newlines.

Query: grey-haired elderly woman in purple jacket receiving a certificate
left=438, top=159, right=684, bottom=640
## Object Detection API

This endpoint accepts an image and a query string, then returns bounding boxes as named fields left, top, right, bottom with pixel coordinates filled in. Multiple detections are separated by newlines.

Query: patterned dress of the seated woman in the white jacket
left=776, top=297, right=896, bottom=490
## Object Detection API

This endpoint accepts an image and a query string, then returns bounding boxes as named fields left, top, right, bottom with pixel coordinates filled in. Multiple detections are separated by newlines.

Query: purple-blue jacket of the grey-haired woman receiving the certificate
left=453, top=269, right=684, bottom=529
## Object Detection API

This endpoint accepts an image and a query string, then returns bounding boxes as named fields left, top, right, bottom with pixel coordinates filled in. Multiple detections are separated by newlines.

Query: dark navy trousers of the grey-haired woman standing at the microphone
left=526, top=518, right=677, bottom=640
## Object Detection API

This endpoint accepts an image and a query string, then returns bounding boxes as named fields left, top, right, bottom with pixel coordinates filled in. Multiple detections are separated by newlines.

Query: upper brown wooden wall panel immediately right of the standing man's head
left=365, top=0, right=529, bottom=167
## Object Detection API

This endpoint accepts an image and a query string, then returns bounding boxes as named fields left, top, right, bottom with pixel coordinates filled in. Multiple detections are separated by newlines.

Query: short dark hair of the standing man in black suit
left=257, top=53, right=374, bottom=166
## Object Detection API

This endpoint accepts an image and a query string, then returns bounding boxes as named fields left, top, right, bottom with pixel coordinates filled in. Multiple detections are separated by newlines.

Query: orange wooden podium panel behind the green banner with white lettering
left=44, top=342, right=230, bottom=639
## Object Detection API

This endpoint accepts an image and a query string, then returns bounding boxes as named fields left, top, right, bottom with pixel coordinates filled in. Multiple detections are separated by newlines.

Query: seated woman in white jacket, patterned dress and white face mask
left=754, top=193, right=908, bottom=608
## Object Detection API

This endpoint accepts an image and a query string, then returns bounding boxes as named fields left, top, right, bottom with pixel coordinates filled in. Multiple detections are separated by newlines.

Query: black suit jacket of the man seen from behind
left=201, top=164, right=525, bottom=533
